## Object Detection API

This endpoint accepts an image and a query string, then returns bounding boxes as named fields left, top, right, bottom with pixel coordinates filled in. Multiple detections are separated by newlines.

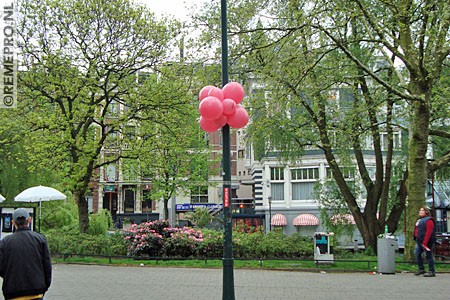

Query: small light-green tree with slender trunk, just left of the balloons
left=131, top=63, right=212, bottom=219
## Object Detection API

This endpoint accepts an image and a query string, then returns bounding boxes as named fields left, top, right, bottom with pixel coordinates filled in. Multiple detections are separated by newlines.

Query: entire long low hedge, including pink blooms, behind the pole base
left=46, top=221, right=313, bottom=258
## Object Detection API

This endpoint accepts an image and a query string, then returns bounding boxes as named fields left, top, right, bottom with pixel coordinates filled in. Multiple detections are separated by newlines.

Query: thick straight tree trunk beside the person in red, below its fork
left=405, top=97, right=430, bottom=260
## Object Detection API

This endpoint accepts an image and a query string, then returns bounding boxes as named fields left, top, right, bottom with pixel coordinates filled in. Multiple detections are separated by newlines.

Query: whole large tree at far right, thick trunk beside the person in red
left=309, top=0, right=450, bottom=257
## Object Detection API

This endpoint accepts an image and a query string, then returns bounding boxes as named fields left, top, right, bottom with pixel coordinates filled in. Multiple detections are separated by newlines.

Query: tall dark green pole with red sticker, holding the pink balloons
left=221, top=0, right=235, bottom=300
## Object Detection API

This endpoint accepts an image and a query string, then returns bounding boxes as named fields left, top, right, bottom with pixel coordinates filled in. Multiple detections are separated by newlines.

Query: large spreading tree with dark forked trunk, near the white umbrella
left=18, top=0, right=181, bottom=232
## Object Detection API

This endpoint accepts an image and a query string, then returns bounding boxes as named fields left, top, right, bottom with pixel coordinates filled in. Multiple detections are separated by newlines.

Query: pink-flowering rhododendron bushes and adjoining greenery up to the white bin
left=124, top=220, right=314, bottom=258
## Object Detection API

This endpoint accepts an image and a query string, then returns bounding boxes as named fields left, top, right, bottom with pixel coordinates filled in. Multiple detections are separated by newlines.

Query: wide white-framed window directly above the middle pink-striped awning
left=291, top=168, right=319, bottom=200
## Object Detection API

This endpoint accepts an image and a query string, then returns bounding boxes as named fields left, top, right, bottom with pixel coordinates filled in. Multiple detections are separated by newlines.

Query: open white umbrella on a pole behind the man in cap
left=14, top=185, right=67, bottom=231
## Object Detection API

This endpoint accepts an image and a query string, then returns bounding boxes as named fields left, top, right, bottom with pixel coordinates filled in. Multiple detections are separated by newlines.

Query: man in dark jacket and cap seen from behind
left=0, top=208, right=52, bottom=300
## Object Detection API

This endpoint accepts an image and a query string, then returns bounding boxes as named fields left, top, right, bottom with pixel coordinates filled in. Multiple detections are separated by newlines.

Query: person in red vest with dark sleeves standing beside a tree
left=414, top=207, right=436, bottom=277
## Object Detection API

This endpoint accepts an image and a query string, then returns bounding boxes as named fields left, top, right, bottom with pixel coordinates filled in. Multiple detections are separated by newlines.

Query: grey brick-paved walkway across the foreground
left=1, top=264, right=450, bottom=300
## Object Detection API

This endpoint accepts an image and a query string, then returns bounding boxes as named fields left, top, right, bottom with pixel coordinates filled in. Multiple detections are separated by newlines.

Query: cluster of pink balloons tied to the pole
left=198, top=82, right=248, bottom=132
